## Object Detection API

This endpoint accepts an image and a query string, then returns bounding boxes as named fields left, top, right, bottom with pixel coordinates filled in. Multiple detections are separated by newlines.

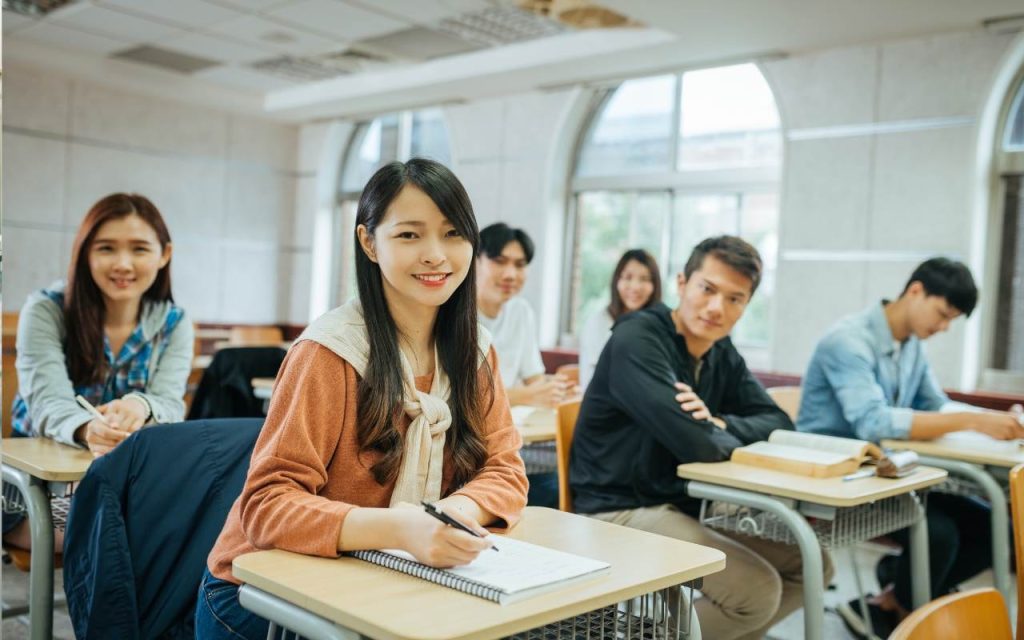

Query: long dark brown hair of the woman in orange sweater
left=355, top=158, right=494, bottom=487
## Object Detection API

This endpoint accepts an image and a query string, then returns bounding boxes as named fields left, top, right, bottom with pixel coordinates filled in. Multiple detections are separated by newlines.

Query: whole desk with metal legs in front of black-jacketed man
left=678, top=462, right=947, bottom=640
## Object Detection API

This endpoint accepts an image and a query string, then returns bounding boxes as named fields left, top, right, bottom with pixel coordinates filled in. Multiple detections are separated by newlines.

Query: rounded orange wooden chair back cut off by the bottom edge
left=889, top=588, right=1013, bottom=640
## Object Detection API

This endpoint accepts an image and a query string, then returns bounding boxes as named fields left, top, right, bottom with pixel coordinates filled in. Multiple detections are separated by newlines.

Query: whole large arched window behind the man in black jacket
left=563, top=65, right=782, bottom=360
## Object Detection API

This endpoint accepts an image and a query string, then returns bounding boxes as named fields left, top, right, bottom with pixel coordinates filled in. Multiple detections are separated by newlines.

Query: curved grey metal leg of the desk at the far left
left=3, top=465, right=53, bottom=640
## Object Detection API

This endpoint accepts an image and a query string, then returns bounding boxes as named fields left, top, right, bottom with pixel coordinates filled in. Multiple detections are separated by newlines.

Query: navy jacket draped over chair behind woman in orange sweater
left=63, top=419, right=263, bottom=640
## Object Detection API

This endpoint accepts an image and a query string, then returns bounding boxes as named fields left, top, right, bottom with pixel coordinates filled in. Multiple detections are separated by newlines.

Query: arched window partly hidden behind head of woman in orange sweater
left=332, top=109, right=452, bottom=304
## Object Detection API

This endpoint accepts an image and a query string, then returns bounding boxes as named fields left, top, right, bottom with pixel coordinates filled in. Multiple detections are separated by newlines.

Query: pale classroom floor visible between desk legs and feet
left=0, top=544, right=1017, bottom=640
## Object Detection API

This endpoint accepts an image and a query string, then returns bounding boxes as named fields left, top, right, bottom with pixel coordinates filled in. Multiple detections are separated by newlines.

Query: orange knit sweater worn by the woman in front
left=208, top=341, right=527, bottom=583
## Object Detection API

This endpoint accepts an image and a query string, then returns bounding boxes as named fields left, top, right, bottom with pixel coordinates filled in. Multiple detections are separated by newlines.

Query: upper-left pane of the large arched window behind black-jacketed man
left=577, top=76, right=676, bottom=176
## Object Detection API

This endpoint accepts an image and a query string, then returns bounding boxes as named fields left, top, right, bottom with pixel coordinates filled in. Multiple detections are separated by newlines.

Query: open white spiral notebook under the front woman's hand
left=348, top=536, right=611, bottom=604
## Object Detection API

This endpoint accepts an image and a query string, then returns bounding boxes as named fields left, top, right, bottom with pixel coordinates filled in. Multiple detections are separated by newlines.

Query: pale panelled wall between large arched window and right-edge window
left=763, top=32, right=1012, bottom=386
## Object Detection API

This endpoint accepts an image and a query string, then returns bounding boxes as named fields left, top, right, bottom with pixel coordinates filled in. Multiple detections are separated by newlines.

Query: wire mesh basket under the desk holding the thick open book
left=700, top=493, right=925, bottom=549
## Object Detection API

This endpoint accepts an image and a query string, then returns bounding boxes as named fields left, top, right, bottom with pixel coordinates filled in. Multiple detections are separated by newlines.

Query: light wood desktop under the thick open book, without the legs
left=678, top=462, right=946, bottom=507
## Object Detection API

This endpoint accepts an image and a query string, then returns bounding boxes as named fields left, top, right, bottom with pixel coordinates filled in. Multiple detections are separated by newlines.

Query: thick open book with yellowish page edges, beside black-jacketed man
left=732, top=429, right=883, bottom=478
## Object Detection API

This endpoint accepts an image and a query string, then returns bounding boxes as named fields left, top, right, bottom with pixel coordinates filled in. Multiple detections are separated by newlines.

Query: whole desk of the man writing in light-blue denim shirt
left=882, top=440, right=1024, bottom=602
